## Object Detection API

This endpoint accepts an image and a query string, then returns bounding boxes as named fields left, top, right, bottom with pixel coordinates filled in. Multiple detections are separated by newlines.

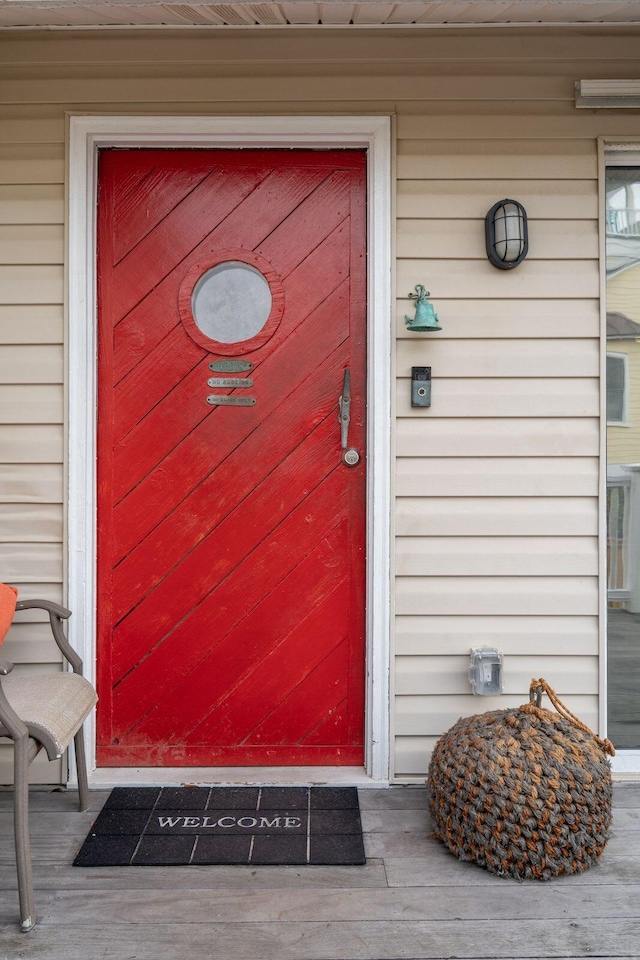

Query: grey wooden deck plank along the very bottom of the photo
left=0, top=917, right=640, bottom=960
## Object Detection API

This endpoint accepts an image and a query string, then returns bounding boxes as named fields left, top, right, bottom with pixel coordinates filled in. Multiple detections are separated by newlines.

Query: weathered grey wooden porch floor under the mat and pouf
left=0, top=783, right=640, bottom=960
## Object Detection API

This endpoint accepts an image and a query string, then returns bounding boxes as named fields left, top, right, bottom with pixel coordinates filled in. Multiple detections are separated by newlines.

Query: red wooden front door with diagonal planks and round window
left=97, top=150, right=366, bottom=766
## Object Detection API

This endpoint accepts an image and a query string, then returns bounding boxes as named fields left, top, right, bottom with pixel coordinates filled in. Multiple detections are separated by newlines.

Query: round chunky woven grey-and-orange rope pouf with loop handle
left=427, top=680, right=615, bottom=880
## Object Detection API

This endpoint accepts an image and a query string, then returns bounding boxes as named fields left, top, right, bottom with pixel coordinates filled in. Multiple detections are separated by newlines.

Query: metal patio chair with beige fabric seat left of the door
left=0, top=600, right=97, bottom=933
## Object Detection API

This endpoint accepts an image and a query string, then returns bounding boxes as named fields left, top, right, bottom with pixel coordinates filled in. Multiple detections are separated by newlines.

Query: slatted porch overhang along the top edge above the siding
left=0, top=0, right=640, bottom=30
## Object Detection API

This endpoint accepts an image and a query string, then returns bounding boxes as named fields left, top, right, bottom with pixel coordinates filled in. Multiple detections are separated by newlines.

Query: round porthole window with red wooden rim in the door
left=178, top=250, right=284, bottom=356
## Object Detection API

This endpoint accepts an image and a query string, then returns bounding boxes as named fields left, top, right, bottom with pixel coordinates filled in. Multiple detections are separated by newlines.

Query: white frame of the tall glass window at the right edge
left=598, top=137, right=640, bottom=777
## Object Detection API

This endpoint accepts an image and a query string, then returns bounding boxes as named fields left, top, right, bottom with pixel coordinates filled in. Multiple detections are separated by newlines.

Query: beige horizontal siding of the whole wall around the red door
left=0, top=28, right=640, bottom=780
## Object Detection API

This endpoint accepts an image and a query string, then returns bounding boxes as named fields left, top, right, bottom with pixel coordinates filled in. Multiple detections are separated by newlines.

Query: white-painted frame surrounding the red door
left=68, top=116, right=392, bottom=785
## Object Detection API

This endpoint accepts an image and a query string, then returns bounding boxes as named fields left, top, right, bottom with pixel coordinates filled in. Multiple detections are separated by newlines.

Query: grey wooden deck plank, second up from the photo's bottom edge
left=0, top=870, right=640, bottom=926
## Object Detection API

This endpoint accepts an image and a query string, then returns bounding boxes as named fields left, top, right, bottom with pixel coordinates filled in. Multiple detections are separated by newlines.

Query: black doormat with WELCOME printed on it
left=74, top=787, right=365, bottom=867
